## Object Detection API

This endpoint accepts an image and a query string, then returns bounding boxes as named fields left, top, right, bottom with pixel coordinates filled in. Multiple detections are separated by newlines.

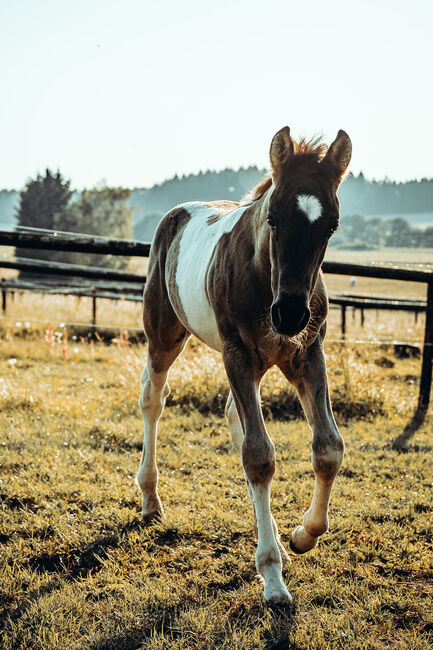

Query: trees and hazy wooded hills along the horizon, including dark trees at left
left=4, top=167, right=433, bottom=268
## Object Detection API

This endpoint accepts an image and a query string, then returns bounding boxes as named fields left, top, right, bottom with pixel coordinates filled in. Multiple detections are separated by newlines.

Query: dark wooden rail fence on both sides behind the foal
left=0, top=225, right=433, bottom=448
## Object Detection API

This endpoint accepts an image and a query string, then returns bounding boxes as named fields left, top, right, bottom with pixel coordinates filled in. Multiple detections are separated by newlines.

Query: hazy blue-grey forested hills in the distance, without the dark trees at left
left=0, top=167, right=433, bottom=247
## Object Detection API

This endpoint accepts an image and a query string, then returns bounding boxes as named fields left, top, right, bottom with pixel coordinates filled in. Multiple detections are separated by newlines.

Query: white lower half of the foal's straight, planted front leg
left=251, top=482, right=292, bottom=603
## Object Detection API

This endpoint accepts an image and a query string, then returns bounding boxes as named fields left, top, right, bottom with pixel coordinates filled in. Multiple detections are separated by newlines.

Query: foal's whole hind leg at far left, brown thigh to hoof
left=136, top=300, right=189, bottom=518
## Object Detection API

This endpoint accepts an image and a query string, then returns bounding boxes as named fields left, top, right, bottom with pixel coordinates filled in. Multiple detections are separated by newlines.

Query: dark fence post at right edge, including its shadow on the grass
left=392, top=280, right=433, bottom=450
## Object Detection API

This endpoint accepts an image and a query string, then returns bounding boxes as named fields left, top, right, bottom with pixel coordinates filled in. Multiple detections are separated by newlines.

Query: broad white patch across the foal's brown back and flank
left=176, top=202, right=247, bottom=350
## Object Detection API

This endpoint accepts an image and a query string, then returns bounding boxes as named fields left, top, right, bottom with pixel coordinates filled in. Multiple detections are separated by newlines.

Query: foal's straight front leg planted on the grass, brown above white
left=223, top=342, right=292, bottom=603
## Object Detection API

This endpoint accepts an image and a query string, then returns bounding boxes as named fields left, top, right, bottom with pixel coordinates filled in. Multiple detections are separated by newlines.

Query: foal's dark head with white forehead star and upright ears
left=267, top=127, right=352, bottom=336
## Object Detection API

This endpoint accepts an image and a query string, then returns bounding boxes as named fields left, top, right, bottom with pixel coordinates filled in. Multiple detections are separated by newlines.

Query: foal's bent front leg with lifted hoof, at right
left=282, top=342, right=344, bottom=553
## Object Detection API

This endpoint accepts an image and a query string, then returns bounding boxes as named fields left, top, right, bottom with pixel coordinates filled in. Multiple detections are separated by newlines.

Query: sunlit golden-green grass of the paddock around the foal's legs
left=0, top=326, right=433, bottom=650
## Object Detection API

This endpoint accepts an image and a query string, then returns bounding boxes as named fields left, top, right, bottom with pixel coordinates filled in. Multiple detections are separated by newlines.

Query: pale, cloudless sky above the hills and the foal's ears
left=0, top=0, right=433, bottom=189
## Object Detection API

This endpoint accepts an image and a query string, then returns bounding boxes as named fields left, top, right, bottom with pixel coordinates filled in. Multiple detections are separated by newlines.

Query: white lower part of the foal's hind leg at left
left=136, top=361, right=170, bottom=516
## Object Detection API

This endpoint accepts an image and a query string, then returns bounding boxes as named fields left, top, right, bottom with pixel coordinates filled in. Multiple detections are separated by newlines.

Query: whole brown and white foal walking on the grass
left=137, top=127, right=351, bottom=603
